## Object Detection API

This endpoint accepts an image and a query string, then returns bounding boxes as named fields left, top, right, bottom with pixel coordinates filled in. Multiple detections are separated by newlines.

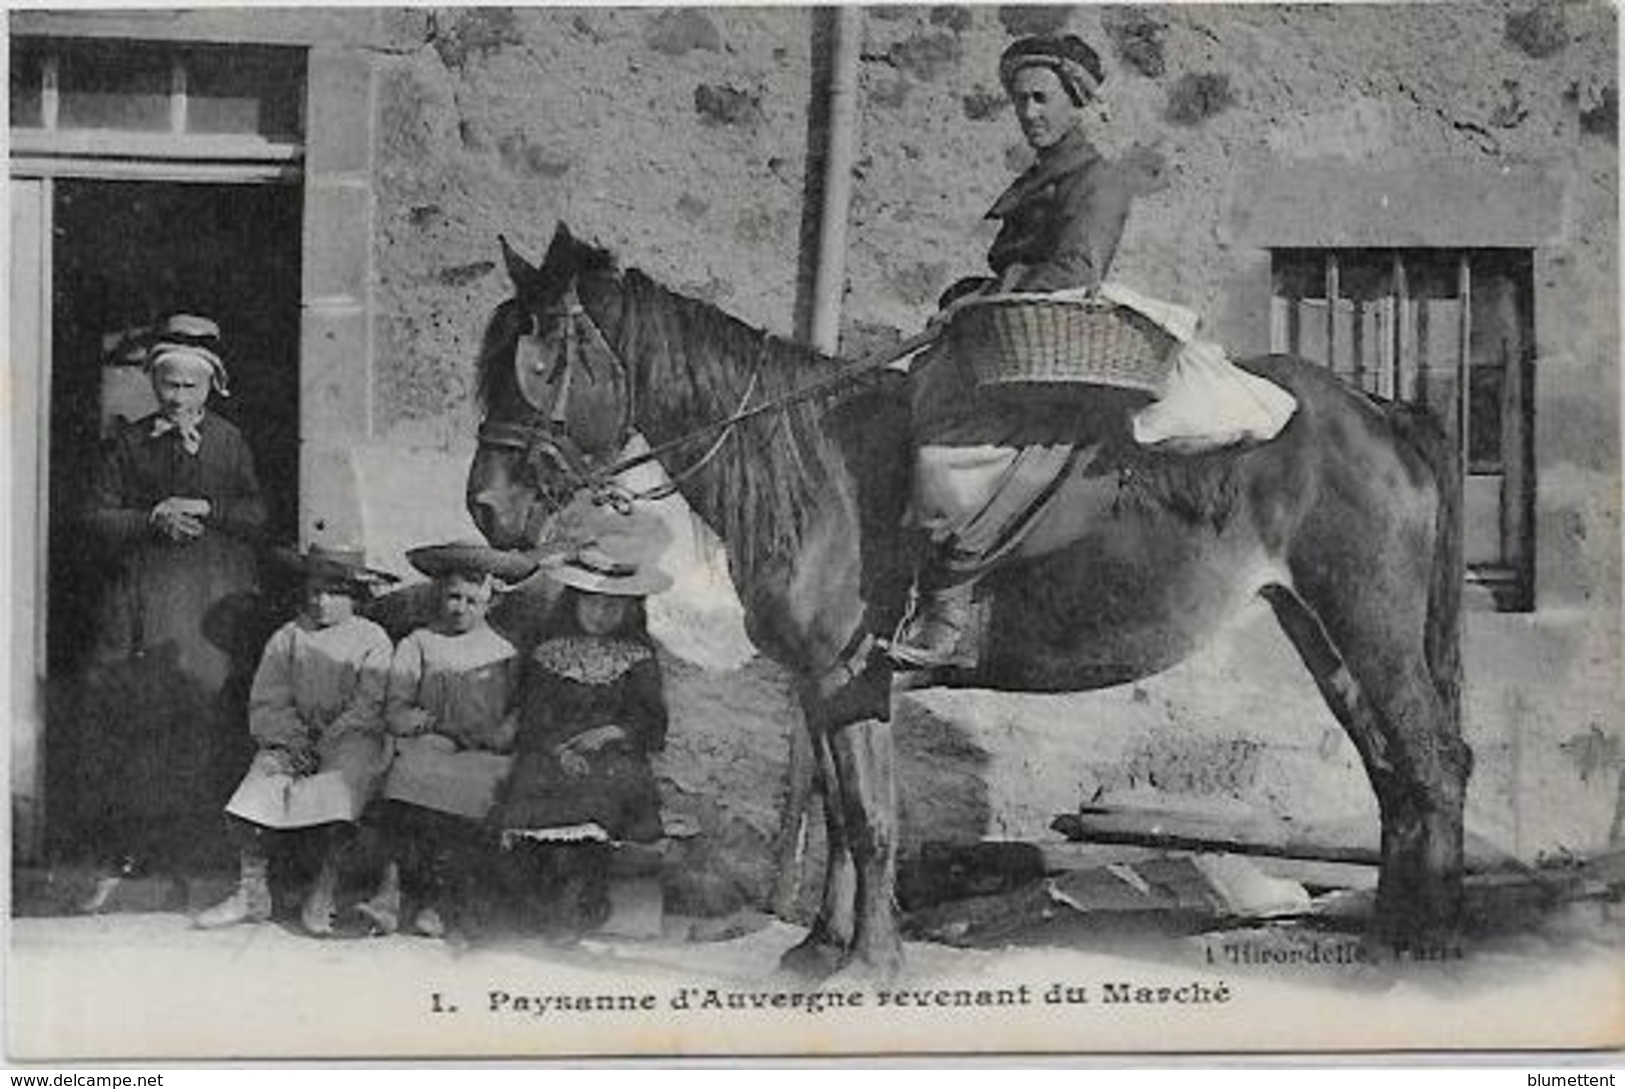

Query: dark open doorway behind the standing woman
left=44, top=179, right=302, bottom=853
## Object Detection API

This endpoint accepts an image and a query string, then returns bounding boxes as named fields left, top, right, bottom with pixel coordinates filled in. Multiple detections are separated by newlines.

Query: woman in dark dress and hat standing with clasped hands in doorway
left=78, top=314, right=267, bottom=910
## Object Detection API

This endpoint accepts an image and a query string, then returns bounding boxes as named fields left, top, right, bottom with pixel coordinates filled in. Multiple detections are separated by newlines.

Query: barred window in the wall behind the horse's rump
left=1269, top=249, right=1534, bottom=611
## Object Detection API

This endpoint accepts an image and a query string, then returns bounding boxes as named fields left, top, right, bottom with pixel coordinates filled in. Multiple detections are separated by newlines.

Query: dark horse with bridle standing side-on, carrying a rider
left=465, top=223, right=1472, bottom=974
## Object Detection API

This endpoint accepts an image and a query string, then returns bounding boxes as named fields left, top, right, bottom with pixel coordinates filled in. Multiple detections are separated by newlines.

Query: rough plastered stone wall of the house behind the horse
left=361, top=0, right=1622, bottom=894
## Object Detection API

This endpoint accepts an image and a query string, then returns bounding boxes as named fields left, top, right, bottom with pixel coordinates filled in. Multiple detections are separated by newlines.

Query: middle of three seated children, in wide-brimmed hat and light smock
left=356, top=541, right=536, bottom=938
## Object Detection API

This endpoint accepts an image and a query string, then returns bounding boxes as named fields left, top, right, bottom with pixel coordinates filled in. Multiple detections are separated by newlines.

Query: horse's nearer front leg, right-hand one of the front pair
left=830, top=718, right=904, bottom=978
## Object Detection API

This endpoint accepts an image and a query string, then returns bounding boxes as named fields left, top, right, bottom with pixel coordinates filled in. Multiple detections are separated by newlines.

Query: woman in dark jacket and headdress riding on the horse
left=891, top=34, right=1133, bottom=668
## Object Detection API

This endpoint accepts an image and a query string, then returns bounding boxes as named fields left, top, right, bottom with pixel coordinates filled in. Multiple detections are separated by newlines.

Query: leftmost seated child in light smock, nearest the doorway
left=197, top=545, right=395, bottom=936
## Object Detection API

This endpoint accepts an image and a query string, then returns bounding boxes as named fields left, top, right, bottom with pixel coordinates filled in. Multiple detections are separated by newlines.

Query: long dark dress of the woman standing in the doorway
left=75, top=413, right=267, bottom=847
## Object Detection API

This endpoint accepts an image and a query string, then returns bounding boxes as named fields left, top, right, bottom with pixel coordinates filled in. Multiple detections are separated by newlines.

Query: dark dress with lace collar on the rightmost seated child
left=492, top=636, right=666, bottom=842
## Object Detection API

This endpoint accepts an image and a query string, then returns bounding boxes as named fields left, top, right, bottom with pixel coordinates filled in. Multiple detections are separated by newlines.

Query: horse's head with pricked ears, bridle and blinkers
left=466, top=223, right=632, bottom=548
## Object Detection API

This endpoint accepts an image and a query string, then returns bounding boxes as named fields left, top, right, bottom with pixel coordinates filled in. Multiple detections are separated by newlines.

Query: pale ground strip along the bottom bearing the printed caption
left=7, top=902, right=1625, bottom=1060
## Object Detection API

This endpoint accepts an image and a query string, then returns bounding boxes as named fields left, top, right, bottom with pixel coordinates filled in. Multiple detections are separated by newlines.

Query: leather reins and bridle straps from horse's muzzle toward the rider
left=479, top=274, right=938, bottom=509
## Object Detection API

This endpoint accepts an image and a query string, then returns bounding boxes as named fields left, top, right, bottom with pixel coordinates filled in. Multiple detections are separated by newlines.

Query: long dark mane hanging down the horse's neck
left=618, top=268, right=845, bottom=580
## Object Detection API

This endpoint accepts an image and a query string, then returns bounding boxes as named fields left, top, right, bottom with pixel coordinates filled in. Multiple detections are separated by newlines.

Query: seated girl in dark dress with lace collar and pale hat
left=492, top=535, right=671, bottom=922
